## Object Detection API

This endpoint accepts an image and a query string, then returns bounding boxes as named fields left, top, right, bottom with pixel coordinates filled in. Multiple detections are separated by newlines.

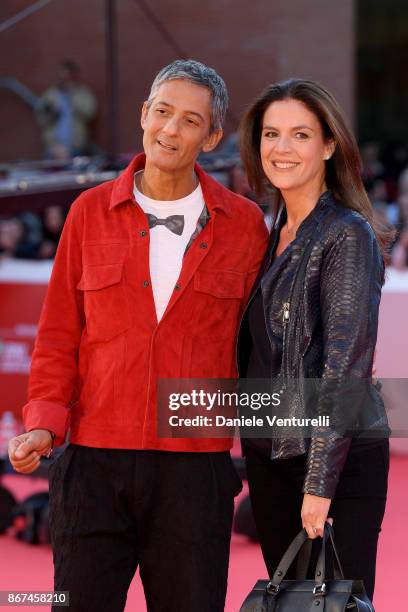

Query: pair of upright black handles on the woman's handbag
left=266, top=522, right=344, bottom=596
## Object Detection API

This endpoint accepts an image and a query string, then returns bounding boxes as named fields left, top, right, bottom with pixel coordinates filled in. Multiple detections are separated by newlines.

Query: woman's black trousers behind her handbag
left=245, top=440, right=389, bottom=599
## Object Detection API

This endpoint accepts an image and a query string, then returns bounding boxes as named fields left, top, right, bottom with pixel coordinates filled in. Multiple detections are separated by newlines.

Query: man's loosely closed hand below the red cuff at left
left=8, top=429, right=52, bottom=474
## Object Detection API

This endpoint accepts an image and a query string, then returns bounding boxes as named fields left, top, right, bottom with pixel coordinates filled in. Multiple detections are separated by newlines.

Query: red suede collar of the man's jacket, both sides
left=109, top=153, right=234, bottom=217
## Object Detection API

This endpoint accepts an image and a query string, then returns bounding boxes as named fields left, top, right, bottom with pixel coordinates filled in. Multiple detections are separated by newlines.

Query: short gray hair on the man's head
left=148, top=60, right=228, bottom=132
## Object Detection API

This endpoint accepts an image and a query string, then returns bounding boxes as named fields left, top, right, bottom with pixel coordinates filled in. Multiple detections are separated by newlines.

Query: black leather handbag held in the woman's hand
left=240, top=523, right=374, bottom=612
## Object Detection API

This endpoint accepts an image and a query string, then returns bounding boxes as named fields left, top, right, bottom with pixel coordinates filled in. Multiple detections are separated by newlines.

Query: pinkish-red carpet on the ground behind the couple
left=0, top=456, right=408, bottom=612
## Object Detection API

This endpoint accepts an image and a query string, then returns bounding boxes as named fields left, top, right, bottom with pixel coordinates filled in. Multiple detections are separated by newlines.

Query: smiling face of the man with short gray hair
left=141, top=79, right=222, bottom=173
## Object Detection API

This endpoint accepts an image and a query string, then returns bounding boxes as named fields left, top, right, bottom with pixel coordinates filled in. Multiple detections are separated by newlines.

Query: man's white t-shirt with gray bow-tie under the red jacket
left=134, top=175, right=204, bottom=321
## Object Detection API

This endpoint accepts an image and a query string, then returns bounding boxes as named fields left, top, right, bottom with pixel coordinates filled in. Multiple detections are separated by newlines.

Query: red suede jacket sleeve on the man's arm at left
left=23, top=197, right=84, bottom=444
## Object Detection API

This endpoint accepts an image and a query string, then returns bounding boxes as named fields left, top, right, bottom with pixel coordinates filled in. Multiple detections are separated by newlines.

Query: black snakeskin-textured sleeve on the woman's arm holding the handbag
left=303, top=218, right=384, bottom=498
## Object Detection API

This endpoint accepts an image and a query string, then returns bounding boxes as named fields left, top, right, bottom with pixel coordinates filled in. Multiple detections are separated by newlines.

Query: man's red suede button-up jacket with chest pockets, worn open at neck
left=23, top=155, right=268, bottom=451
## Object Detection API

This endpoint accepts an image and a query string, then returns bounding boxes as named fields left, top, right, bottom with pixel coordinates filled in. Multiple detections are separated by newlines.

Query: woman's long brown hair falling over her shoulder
left=240, top=79, right=394, bottom=254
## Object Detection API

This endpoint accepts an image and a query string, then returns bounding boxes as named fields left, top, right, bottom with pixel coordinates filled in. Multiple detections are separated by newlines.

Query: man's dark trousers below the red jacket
left=50, top=445, right=241, bottom=612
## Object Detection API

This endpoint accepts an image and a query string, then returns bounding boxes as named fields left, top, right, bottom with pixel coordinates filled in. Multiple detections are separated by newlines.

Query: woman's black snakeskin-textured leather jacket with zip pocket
left=238, top=191, right=384, bottom=498
